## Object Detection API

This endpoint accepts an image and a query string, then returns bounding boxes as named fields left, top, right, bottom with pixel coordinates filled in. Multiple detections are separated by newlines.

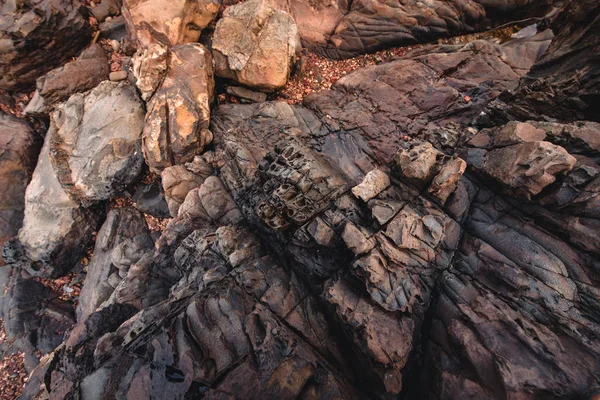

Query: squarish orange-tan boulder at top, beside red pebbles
left=212, top=0, right=301, bottom=91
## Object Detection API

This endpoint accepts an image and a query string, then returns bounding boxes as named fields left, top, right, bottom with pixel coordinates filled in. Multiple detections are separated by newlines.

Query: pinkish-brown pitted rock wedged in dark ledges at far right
left=483, top=142, right=577, bottom=200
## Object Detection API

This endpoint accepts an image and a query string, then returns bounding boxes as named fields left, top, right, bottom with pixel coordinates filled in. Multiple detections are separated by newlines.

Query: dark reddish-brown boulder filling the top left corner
left=0, top=0, right=92, bottom=90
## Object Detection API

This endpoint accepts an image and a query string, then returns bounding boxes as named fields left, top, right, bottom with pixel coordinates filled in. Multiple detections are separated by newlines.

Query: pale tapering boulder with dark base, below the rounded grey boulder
left=3, top=136, right=95, bottom=277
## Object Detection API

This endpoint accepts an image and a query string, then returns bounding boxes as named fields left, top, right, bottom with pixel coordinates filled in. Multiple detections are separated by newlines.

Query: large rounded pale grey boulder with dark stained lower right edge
left=48, top=81, right=144, bottom=204
